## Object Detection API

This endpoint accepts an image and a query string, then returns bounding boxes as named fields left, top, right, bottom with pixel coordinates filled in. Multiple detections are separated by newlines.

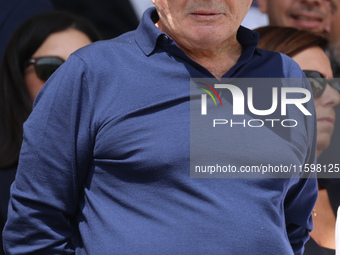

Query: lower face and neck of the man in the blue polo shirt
left=152, top=0, right=252, bottom=78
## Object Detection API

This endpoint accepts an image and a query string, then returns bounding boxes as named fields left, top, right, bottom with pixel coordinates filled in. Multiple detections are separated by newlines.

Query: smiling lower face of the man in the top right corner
left=257, top=0, right=337, bottom=36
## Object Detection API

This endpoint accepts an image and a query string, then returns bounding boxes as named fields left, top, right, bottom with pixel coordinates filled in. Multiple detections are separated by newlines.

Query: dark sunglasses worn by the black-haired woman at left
left=26, top=57, right=65, bottom=81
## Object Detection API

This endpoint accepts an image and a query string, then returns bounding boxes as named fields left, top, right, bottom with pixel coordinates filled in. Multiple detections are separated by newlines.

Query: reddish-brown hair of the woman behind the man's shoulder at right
left=254, top=26, right=328, bottom=57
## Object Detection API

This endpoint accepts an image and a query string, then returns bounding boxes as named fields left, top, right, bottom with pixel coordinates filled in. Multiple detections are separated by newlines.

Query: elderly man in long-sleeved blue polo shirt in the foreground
left=4, top=0, right=317, bottom=255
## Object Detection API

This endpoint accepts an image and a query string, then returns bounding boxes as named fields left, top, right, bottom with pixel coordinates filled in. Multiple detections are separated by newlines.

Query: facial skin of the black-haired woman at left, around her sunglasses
left=25, top=28, right=91, bottom=101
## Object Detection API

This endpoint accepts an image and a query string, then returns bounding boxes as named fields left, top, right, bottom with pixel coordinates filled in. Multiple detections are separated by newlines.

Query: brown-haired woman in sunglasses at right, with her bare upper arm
left=255, top=26, right=340, bottom=255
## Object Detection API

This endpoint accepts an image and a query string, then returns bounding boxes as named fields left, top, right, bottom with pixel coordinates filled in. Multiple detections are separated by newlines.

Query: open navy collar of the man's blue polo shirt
left=135, top=7, right=260, bottom=59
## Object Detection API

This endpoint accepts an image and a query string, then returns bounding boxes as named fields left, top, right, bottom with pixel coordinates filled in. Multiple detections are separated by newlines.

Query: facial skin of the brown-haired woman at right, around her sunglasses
left=293, top=47, right=340, bottom=157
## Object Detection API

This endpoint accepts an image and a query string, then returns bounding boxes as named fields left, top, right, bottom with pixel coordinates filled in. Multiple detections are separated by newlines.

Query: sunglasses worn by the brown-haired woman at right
left=303, top=70, right=340, bottom=98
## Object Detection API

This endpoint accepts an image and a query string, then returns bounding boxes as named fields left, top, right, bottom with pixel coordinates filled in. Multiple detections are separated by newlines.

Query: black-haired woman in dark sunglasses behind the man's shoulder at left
left=0, top=11, right=100, bottom=254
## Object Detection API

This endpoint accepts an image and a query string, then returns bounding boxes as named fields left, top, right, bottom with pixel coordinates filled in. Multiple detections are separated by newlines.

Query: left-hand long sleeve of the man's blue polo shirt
left=3, top=56, right=93, bottom=254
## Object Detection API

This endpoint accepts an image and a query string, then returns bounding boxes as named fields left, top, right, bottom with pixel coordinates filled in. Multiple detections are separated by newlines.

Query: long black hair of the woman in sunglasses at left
left=0, top=11, right=101, bottom=168
